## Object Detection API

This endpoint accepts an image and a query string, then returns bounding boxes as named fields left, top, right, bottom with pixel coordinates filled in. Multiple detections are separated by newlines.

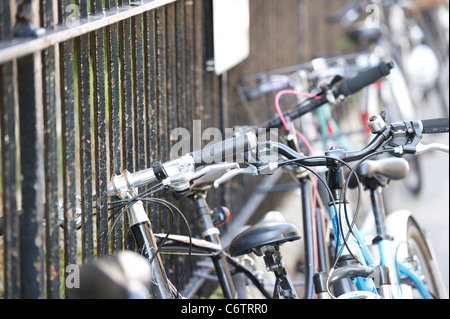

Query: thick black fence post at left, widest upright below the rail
left=17, top=54, right=44, bottom=298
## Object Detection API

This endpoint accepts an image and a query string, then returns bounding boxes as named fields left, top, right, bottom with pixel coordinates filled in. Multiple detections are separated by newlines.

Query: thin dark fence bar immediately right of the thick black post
left=41, top=0, right=60, bottom=299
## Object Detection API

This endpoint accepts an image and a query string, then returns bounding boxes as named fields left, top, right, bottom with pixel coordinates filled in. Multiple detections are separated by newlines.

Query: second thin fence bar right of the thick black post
left=58, top=0, right=77, bottom=297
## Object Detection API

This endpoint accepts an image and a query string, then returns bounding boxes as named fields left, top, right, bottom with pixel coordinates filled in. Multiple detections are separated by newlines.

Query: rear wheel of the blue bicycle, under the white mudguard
left=401, top=218, right=445, bottom=299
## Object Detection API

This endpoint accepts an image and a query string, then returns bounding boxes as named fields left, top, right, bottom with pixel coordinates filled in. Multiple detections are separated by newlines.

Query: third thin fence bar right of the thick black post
left=77, top=0, right=94, bottom=261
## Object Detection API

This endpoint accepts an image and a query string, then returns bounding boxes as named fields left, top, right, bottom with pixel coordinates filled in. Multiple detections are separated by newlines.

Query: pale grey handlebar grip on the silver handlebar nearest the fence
left=191, top=132, right=257, bottom=164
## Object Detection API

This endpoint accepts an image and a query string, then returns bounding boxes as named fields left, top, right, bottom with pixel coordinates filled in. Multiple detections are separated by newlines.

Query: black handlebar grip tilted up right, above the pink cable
left=338, top=62, right=394, bottom=96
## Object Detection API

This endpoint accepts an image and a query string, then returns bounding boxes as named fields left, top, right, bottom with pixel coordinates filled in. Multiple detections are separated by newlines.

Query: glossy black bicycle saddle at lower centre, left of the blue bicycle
left=229, top=212, right=301, bottom=257
